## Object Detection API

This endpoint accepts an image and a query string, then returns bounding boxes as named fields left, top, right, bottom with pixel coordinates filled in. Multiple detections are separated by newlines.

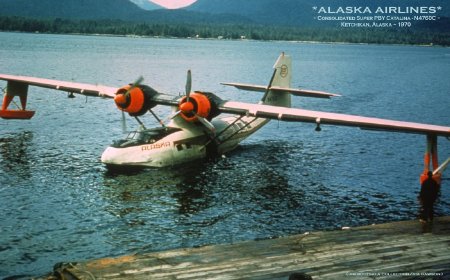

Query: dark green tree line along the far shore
left=0, top=16, right=450, bottom=46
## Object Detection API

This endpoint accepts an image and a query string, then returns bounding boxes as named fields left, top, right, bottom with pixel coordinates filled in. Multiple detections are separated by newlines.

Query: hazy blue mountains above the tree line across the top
left=0, top=0, right=450, bottom=27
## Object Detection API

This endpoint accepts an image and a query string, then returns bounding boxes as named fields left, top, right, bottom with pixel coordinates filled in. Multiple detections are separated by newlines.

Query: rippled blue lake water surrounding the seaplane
left=0, top=33, right=450, bottom=278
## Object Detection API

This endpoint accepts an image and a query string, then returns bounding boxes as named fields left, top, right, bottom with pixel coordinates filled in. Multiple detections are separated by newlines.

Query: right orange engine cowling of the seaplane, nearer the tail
left=179, top=92, right=212, bottom=122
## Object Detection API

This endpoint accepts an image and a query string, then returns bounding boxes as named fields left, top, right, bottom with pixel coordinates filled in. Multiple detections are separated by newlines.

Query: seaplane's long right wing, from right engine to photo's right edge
left=219, top=101, right=450, bottom=137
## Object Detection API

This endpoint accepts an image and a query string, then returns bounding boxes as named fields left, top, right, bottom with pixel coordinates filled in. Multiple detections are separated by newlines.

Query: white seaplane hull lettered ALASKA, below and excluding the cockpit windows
left=101, top=116, right=268, bottom=168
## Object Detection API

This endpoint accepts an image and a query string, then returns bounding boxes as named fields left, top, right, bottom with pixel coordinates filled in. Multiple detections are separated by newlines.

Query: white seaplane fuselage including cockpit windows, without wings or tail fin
left=101, top=116, right=268, bottom=167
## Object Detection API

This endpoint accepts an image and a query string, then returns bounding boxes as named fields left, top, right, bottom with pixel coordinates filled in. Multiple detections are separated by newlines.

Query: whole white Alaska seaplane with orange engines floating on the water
left=0, top=53, right=450, bottom=182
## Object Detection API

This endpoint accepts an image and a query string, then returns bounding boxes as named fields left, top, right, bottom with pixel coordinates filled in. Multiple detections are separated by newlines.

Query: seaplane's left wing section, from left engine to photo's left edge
left=0, top=74, right=118, bottom=98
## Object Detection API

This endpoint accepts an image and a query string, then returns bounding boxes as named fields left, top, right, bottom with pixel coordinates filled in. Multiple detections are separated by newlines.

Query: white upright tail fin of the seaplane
left=262, top=52, right=292, bottom=107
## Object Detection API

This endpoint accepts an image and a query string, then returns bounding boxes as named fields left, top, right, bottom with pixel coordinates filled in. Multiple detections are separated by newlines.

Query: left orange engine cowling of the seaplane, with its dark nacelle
left=114, top=85, right=157, bottom=116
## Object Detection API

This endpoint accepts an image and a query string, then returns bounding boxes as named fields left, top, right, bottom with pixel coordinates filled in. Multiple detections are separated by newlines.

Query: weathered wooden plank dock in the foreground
left=39, top=217, right=450, bottom=280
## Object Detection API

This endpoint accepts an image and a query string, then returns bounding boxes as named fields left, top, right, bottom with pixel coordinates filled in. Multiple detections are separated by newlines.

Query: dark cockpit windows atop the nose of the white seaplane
left=112, top=127, right=181, bottom=148
